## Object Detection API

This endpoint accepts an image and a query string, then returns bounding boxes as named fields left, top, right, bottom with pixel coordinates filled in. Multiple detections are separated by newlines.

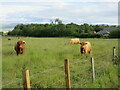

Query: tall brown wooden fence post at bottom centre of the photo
left=64, top=59, right=71, bottom=90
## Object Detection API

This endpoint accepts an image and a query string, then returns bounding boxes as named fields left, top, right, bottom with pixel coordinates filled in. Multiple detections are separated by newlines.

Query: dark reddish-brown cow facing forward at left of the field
left=14, top=40, right=26, bottom=55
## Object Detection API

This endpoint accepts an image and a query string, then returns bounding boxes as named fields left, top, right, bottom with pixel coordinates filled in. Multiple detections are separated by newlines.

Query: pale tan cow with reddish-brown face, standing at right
left=80, top=42, right=92, bottom=54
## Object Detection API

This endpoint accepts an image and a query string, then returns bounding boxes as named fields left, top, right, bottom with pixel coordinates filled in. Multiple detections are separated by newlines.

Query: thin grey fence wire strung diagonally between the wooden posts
left=0, top=52, right=115, bottom=87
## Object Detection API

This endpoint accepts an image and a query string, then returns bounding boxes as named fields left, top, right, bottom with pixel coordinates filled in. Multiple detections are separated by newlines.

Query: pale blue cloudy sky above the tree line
left=0, top=0, right=118, bottom=25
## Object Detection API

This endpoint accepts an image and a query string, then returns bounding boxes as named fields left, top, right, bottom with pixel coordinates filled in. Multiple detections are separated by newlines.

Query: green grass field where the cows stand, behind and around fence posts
left=2, top=37, right=118, bottom=88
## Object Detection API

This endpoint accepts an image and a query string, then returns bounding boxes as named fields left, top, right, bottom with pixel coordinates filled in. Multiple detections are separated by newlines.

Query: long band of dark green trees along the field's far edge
left=8, top=19, right=116, bottom=38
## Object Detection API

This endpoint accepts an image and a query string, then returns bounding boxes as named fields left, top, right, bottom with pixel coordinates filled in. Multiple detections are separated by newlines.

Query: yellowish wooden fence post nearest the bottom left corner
left=22, top=70, right=31, bottom=90
